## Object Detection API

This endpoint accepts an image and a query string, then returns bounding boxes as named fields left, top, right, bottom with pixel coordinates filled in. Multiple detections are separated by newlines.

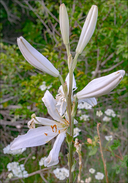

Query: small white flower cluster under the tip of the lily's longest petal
left=3, top=145, right=26, bottom=155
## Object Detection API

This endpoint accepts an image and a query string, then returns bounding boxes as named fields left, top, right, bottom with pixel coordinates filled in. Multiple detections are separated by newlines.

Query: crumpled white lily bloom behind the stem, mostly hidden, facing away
left=56, top=74, right=97, bottom=115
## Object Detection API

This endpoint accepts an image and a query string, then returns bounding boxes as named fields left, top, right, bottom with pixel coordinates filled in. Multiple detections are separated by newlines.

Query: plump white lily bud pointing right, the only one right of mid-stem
left=76, top=70, right=125, bottom=99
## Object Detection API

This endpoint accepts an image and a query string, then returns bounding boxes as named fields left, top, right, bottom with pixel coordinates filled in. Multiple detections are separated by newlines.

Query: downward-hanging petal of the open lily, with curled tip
left=44, top=132, right=66, bottom=167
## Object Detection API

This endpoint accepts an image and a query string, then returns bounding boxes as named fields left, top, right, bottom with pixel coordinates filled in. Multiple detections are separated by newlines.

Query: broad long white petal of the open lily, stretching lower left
left=10, top=126, right=58, bottom=150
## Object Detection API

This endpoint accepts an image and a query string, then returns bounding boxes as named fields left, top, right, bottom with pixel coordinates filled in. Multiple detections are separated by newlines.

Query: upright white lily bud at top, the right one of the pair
left=76, top=5, right=98, bottom=54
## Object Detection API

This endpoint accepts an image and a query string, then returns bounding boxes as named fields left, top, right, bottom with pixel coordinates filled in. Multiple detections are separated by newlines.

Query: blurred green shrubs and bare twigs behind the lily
left=0, top=0, right=128, bottom=183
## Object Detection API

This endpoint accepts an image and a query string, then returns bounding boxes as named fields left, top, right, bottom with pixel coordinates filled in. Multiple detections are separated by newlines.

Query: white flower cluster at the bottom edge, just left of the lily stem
left=53, top=168, right=69, bottom=180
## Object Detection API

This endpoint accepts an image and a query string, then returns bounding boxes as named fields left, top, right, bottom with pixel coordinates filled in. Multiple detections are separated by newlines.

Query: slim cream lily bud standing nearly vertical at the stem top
left=59, top=4, right=69, bottom=45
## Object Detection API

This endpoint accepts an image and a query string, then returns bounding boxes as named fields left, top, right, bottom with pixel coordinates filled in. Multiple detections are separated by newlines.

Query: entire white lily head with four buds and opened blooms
left=7, top=4, right=125, bottom=172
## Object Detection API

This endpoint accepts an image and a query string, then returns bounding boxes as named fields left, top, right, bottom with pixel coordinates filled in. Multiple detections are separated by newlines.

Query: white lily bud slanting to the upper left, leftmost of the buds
left=17, top=37, right=59, bottom=77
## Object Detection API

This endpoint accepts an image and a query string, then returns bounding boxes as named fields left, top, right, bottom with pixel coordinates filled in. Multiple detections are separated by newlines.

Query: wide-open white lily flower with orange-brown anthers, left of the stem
left=10, top=90, right=69, bottom=167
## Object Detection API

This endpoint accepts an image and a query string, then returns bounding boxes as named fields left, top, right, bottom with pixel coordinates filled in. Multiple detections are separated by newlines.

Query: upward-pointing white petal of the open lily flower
left=42, top=90, right=65, bottom=123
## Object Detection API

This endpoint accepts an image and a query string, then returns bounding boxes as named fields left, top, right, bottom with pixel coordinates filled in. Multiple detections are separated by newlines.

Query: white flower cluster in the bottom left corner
left=7, top=162, right=28, bottom=178
